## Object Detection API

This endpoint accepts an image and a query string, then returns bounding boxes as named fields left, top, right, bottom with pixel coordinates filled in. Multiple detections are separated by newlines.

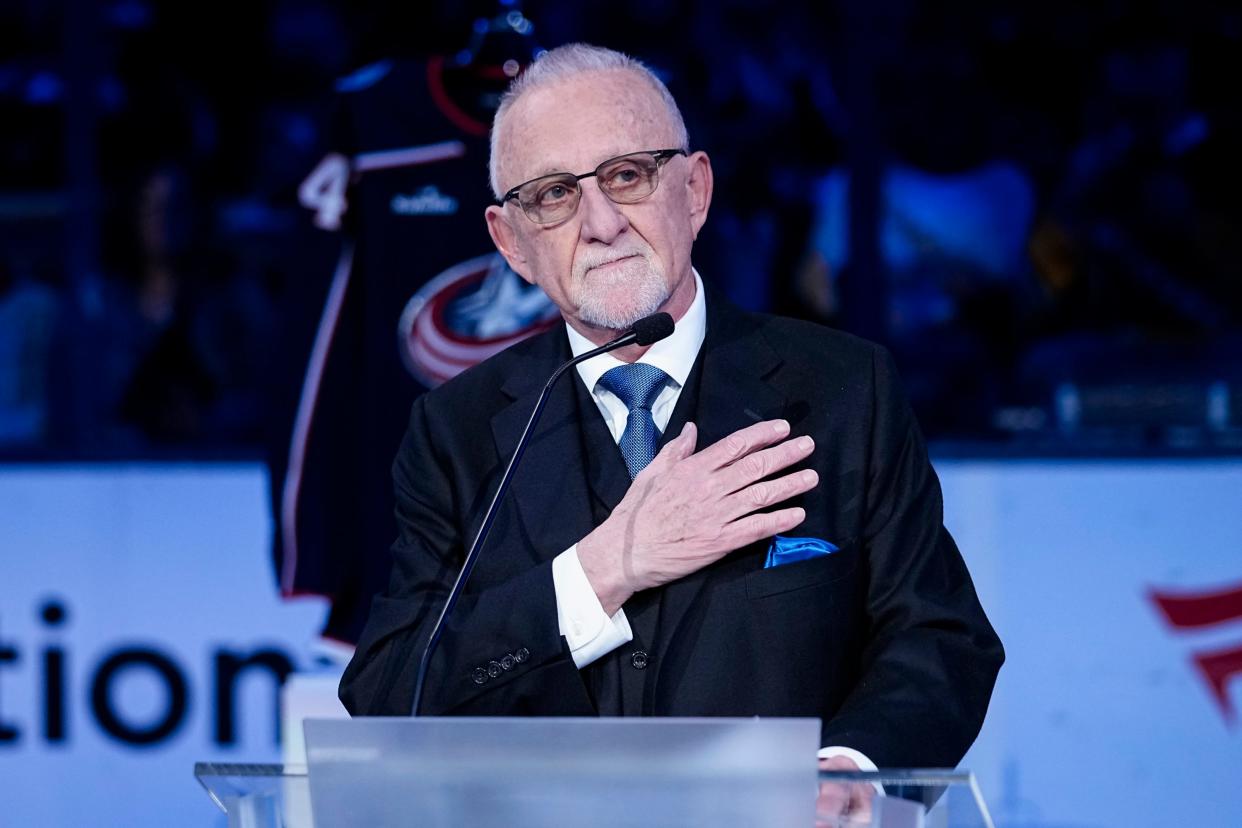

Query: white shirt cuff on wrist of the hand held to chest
left=551, top=544, right=630, bottom=670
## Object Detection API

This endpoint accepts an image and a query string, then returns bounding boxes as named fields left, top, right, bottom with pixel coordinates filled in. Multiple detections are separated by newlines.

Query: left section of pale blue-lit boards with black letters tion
left=0, top=466, right=324, bottom=827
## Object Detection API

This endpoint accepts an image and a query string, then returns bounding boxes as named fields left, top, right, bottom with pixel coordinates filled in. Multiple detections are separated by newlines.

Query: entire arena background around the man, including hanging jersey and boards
left=0, top=0, right=1242, bottom=828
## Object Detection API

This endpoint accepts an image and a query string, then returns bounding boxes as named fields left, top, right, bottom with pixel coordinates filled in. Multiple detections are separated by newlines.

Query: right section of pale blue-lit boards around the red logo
left=936, top=461, right=1242, bottom=828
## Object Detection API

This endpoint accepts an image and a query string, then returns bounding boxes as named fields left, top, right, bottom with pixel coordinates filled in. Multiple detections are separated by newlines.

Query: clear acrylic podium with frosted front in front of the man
left=195, top=719, right=992, bottom=828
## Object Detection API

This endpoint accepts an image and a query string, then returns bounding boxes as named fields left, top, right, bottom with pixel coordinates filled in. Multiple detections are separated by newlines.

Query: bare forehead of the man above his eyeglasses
left=501, top=71, right=674, bottom=186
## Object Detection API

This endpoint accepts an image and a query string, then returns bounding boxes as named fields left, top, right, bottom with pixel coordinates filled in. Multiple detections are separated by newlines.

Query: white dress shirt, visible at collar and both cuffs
left=551, top=271, right=883, bottom=779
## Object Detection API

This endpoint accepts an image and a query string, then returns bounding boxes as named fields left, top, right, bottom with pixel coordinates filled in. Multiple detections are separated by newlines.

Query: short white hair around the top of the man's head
left=487, top=43, right=691, bottom=199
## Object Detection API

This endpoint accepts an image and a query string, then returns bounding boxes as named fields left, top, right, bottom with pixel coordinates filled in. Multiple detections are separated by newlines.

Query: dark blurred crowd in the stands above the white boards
left=0, top=0, right=1242, bottom=458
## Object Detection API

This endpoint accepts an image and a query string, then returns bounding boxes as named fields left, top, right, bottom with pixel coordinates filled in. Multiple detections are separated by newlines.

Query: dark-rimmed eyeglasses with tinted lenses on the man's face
left=501, top=149, right=686, bottom=225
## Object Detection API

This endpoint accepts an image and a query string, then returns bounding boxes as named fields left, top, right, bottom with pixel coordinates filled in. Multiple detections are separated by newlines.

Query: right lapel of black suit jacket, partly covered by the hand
left=652, top=292, right=786, bottom=700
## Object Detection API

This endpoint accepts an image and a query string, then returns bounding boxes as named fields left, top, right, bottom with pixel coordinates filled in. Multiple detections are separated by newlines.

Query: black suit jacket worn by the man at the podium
left=342, top=293, right=1004, bottom=767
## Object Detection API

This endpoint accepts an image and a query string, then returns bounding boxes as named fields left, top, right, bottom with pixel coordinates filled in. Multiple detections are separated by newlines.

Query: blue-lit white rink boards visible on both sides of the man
left=0, top=461, right=1242, bottom=828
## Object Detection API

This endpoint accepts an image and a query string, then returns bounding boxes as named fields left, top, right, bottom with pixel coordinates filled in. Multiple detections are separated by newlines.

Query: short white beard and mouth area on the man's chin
left=570, top=251, right=669, bottom=330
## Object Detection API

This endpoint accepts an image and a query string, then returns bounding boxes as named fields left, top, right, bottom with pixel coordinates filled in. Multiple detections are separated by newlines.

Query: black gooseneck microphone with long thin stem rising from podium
left=410, top=313, right=673, bottom=716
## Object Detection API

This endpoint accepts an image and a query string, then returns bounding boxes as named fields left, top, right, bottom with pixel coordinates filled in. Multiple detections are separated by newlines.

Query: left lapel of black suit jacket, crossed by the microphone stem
left=492, top=326, right=602, bottom=560
